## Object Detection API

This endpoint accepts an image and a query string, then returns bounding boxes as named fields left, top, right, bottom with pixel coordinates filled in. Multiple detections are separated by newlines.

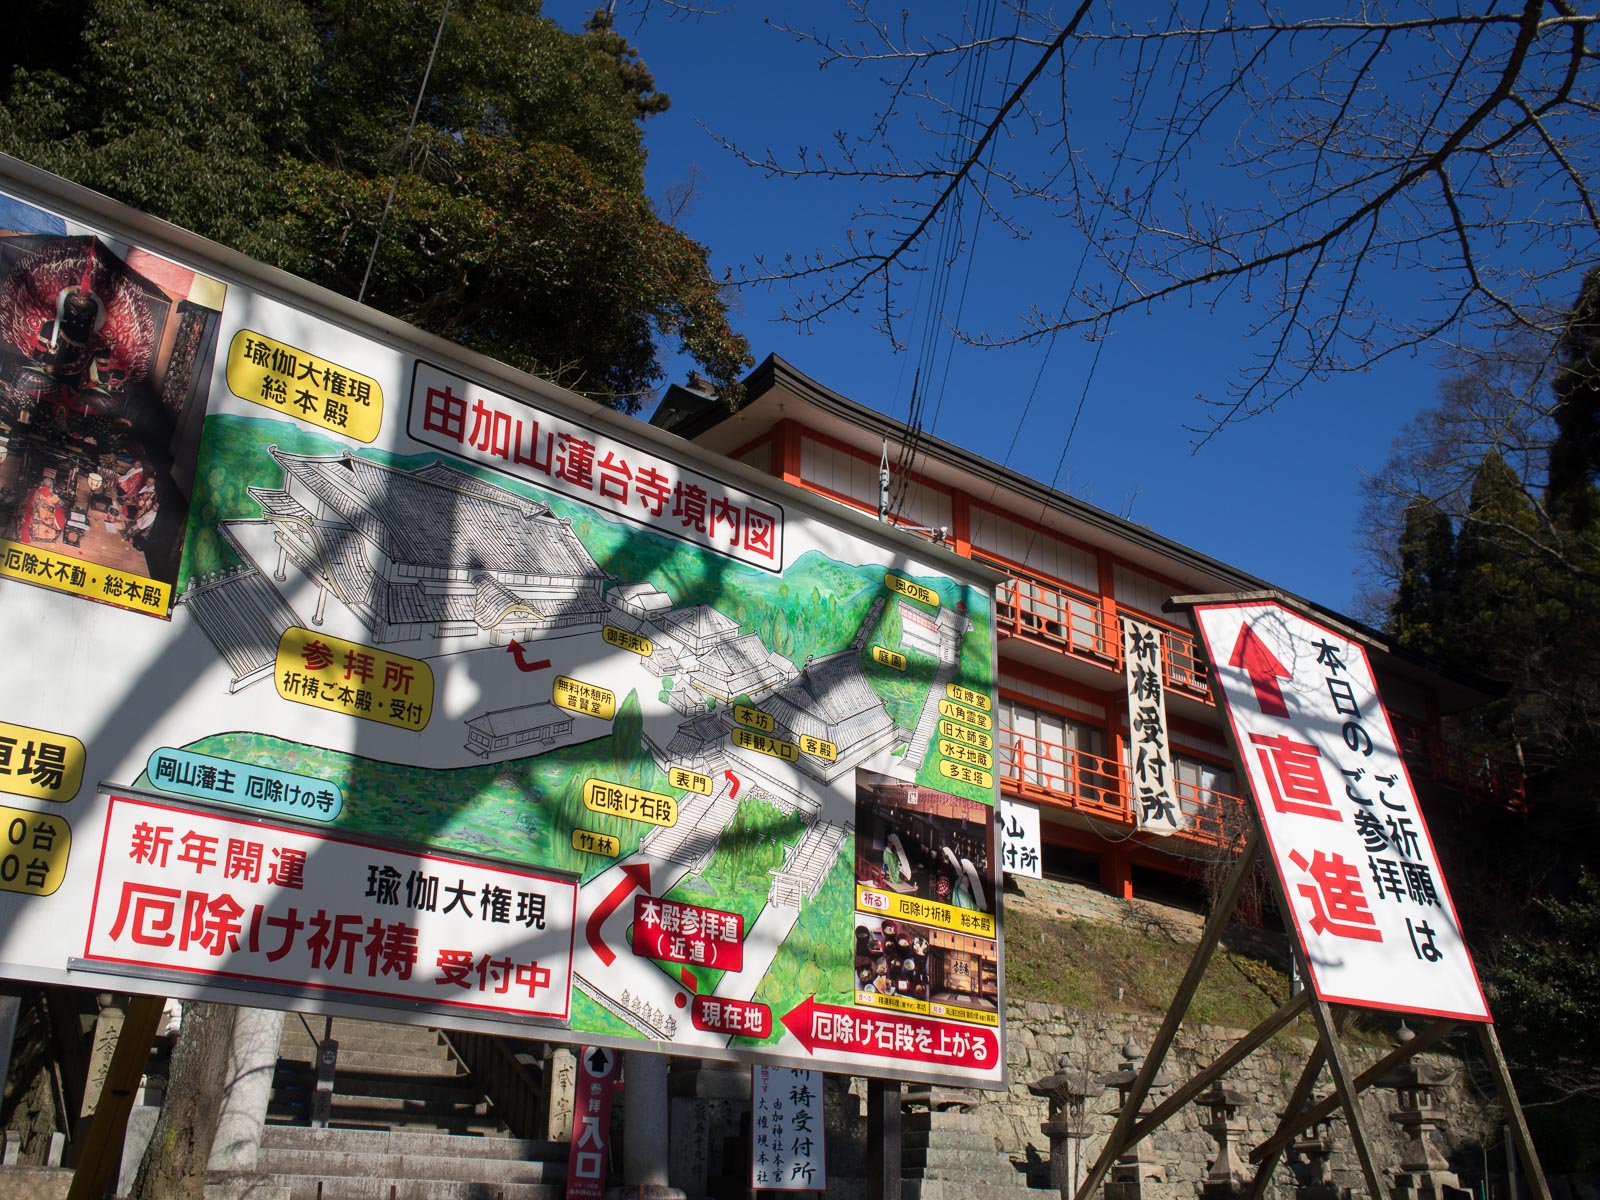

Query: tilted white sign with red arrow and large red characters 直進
left=1195, top=602, right=1490, bottom=1021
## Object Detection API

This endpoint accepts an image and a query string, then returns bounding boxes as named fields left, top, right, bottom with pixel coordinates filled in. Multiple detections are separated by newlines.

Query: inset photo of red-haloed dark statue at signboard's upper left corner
left=0, top=198, right=224, bottom=618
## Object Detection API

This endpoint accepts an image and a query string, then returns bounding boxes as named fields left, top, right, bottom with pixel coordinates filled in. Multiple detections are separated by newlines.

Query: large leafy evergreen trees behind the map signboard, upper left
left=0, top=0, right=750, bottom=411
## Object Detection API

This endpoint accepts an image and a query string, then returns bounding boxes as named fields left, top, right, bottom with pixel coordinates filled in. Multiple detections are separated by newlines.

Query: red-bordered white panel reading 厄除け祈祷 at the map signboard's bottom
left=83, top=795, right=578, bottom=1021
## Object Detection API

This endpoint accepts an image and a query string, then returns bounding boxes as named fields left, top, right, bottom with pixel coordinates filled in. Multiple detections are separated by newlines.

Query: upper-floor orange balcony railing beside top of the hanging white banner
left=995, top=576, right=1211, bottom=704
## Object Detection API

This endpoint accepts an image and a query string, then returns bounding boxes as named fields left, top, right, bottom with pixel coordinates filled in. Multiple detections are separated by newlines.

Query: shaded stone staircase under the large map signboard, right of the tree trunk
left=240, top=1014, right=566, bottom=1200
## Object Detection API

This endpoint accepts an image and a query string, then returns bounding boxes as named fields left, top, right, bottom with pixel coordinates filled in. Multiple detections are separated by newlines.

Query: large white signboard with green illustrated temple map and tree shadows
left=0, top=165, right=1005, bottom=1086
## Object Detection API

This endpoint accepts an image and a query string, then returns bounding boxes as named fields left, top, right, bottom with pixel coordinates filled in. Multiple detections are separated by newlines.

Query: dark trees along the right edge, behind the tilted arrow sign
left=1384, top=274, right=1600, bottom=1170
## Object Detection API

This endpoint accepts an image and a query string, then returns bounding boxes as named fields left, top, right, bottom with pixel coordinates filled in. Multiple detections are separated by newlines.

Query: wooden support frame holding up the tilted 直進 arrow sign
left=1075, top=590, right=1550, bottom=1200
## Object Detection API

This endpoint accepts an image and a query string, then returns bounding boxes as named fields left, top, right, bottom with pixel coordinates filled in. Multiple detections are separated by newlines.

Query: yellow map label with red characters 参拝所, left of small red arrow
left=272, top=626, right=434, bottom=730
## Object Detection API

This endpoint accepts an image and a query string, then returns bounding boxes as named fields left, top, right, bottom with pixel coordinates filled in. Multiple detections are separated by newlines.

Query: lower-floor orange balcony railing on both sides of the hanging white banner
left=995, top=728, right=1245, bottom=846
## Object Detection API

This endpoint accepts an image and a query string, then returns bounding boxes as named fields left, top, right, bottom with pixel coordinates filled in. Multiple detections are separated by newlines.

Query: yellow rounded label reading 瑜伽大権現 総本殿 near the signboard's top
left=227, top=330, right=384, bottom=442
